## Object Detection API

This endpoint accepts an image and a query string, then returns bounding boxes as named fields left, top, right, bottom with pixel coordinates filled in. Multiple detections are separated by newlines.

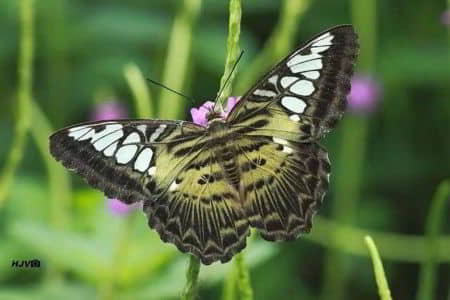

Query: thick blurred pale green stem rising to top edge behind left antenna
left=158, top=0, right=201, bottom=119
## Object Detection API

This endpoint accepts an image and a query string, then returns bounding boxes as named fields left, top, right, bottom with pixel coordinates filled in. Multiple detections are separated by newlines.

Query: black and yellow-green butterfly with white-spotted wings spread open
left=50, top=25, right=359, bottom=264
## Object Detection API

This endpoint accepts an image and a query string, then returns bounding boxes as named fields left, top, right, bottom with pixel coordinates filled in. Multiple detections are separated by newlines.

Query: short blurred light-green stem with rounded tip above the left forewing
left=124, top=63, right=154, bottom=119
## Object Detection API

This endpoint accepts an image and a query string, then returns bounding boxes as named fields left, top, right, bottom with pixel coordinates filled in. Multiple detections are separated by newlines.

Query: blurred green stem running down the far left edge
left=0, top=0, right=33, bottom=208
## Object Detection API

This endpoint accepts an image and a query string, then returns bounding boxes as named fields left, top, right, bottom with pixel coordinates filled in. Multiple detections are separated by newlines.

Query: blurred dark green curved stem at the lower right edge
left=417, top=180, right=450, bottom=300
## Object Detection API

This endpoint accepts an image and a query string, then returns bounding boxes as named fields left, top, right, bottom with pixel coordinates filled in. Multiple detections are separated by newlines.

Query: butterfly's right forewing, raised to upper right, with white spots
left=227, top=25, right=359, bottom=142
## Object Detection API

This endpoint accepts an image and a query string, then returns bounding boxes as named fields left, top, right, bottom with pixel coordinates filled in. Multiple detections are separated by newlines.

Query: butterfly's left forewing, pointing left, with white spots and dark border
left=50, top=120, right=204, bottom=203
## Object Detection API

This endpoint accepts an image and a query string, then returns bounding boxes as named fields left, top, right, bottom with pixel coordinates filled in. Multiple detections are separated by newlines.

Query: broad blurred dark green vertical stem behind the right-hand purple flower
left=322, top=0, right=376, bottom=300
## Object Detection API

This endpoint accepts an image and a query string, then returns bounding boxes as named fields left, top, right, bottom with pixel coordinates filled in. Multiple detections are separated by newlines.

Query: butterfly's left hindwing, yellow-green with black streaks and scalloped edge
left=144, top=146, right=250, bottom=264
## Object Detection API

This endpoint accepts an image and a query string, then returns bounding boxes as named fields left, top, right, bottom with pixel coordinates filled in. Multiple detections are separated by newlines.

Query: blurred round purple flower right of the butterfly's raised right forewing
left=348, top=74, right=380, bottom=113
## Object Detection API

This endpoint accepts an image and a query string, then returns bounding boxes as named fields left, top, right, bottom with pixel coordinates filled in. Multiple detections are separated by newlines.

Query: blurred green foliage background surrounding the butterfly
left=0, top=0, right=450, bottom=300
